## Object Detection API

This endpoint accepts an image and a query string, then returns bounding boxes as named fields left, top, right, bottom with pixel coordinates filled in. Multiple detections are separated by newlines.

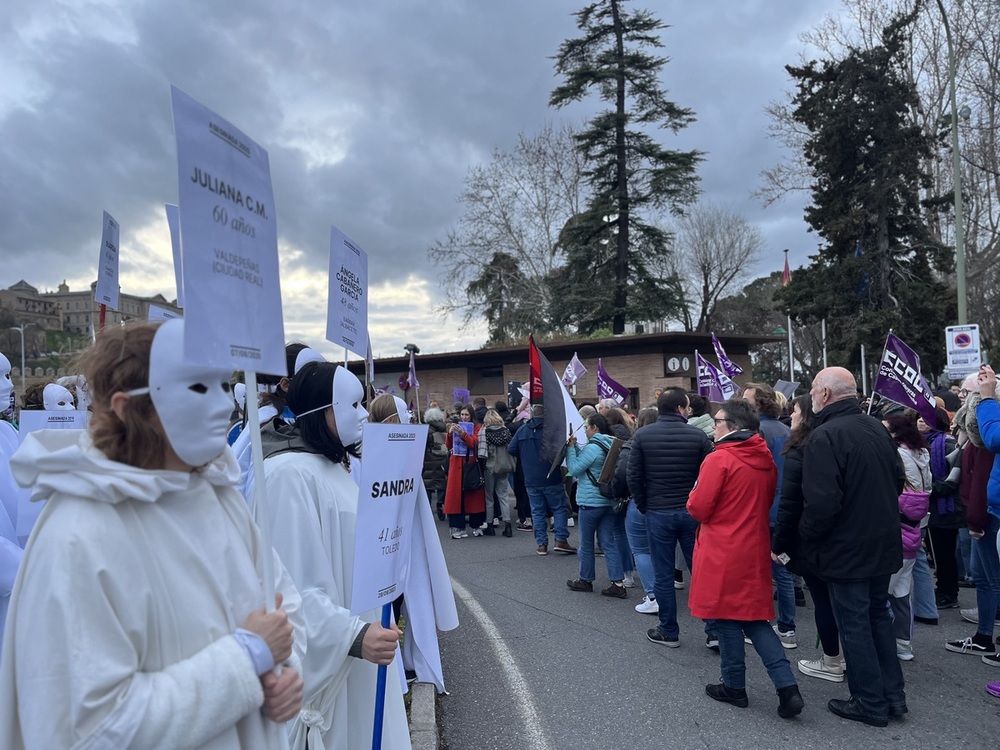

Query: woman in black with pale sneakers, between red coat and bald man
left=771, top=394, right=845, bottom=682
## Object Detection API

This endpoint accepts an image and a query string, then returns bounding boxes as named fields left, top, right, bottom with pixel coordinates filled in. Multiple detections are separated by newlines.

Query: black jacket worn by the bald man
left=799, top=398, right=904, bottom=581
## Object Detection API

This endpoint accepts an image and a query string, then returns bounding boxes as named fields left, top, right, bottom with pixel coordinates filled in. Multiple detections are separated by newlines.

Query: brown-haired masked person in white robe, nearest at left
left=0, top=320, right=305, bottom=750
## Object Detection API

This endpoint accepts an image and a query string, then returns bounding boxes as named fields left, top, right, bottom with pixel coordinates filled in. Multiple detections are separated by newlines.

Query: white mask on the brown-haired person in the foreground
left=129, top=318, right=233, bottom=466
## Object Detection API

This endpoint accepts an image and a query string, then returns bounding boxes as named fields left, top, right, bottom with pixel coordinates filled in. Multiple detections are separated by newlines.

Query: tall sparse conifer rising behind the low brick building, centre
left=549, top=0, right=701, bottom=333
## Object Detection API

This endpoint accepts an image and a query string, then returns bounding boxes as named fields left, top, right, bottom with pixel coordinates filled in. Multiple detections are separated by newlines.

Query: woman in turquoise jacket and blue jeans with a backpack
left=566, top=414, right=628, bottom=599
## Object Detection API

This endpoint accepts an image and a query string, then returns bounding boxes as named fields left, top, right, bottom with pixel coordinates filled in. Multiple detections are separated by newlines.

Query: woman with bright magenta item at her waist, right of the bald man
left=883, top=409, right=933, bottom=661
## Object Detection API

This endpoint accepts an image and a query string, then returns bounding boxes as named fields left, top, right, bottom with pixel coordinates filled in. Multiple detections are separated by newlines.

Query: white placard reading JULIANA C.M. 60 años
left=171, top=87, right=286, bottom=375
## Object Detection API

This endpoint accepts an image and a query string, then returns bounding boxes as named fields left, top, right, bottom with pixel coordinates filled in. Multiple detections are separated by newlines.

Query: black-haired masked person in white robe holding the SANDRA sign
left=255, top=362, right=410, bottom=750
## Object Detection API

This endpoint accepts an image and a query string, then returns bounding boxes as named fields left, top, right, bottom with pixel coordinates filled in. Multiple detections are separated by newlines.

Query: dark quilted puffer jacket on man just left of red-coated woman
left=627, top=414, right=712, bottom=513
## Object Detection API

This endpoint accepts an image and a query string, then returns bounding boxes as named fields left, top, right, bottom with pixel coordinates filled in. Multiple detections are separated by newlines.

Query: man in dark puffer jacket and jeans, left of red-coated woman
left=627, top=388, right=712, bottom=648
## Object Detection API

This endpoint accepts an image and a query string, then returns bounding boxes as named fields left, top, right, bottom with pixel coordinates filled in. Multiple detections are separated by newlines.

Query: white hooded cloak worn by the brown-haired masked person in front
left=0, top=430, right=303, bottom=750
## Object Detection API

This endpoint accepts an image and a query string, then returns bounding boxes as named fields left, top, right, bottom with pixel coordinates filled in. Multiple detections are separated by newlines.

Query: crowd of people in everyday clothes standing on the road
left=425, top=366, right=1000, bottom=727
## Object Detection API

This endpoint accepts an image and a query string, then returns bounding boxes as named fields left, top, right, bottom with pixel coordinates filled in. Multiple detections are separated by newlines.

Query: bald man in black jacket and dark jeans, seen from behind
left=799, top=367, right=907, bottom=727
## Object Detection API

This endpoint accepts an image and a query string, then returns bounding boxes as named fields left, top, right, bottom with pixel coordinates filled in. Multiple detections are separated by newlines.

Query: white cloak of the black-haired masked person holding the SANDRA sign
left=257, top=452, right=410, bottom=750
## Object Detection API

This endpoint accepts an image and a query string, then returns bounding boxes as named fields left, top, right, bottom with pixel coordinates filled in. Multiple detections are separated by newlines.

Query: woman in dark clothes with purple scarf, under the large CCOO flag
left=917, top=407, right=965, bottom=609
